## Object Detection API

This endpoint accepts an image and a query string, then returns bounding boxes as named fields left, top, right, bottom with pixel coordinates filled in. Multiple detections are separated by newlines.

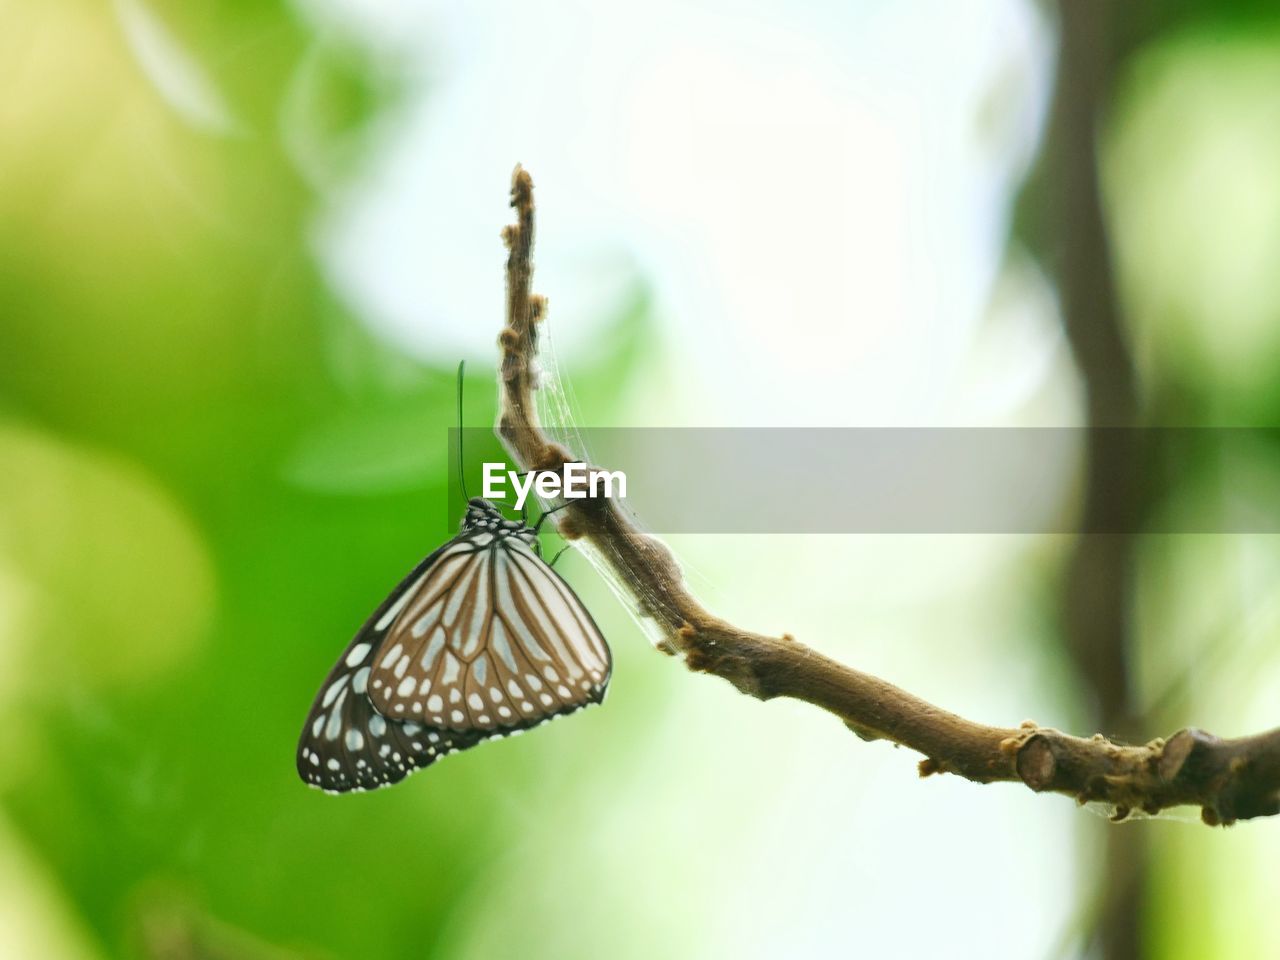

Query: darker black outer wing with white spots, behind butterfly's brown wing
left=297, top=541, right=483, bottom=792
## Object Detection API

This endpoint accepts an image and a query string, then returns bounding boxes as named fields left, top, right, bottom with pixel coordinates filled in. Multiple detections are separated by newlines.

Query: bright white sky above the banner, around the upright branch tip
left=307, top=0, right=1069, bottom=425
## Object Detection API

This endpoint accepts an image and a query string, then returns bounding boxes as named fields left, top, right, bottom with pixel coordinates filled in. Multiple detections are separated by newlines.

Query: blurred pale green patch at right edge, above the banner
left=1103, top=29, right=1280, bottom=422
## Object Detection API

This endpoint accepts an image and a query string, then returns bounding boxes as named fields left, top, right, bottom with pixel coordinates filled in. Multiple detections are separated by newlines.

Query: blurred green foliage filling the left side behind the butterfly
left=0, top=0, right=645, bottom=957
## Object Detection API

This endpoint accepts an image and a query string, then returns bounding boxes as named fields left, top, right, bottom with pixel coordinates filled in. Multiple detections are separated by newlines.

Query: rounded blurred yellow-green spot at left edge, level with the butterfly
left=0, top=426, right=214, bottom=695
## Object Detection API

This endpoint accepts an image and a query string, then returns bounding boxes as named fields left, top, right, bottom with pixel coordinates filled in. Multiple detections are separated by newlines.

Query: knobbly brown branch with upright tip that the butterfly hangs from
left=498, top=166, right=1280, bottom=824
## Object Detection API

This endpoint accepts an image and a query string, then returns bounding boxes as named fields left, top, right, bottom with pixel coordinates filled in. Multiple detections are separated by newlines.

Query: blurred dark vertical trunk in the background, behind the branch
left=1042, top=0, right=1149, bottom=960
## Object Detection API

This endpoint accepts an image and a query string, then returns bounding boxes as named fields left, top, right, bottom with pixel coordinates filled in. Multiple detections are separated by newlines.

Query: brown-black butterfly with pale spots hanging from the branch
left=297, top=497, right=613, bottom=794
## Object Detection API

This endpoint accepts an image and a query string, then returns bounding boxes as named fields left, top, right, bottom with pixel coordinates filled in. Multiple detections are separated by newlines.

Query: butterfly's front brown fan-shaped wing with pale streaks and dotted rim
left=367, top=534, right=612, bottom=736
